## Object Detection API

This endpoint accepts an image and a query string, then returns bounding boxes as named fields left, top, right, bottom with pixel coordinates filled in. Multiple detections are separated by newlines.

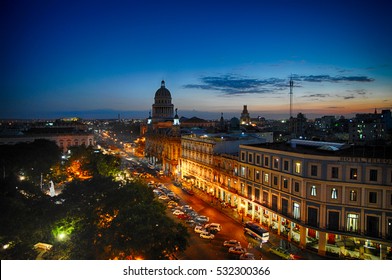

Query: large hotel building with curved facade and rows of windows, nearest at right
left=239, top=140, right=392, bottom=259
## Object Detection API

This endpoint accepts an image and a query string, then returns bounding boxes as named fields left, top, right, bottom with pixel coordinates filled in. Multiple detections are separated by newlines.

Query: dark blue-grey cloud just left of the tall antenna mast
left=184, top=74, right=288, bottom=96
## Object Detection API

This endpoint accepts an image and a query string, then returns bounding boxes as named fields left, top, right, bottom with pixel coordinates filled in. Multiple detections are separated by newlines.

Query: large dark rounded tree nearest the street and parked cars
left=54, top=177, right=188, bottom=259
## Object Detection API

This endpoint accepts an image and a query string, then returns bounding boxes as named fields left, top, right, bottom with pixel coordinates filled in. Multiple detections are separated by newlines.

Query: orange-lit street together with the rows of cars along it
left=97, top=126, right=328, bottom=260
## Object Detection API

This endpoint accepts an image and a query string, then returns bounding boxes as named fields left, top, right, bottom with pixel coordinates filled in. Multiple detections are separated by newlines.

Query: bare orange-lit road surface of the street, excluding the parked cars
left=97, top=129, right=328, bottom=260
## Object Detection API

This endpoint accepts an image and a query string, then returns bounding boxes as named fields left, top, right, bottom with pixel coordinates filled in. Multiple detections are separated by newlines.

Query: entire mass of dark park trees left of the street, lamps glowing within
left=0, top=146, right=188, bottom=260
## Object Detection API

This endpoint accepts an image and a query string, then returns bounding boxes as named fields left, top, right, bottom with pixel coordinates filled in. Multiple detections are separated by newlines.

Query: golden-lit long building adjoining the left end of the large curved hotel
left=181, top=133, right=265, bottom=208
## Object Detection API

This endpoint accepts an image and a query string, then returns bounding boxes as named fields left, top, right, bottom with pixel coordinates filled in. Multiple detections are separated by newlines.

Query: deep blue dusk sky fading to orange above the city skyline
left=0, top=0, right=392, bottom=118
